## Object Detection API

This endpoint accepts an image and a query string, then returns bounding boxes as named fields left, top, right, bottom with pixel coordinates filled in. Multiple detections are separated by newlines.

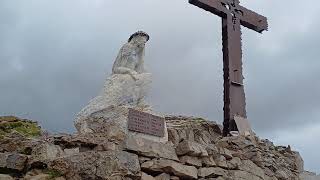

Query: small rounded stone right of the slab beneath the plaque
left=176, top=140, right=208, bottom=157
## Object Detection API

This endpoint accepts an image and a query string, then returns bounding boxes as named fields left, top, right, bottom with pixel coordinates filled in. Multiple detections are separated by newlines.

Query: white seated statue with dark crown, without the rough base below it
left=77, top=31, right=151, bottom=120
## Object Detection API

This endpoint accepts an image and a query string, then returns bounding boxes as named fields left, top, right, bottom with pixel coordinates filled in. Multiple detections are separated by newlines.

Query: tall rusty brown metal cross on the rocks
left=189, top=0, right=268, bottom=136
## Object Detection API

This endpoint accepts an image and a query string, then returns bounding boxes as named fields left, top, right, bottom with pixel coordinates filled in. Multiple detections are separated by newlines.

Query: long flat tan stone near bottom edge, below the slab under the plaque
left=141, top=159, right=197, bottom=179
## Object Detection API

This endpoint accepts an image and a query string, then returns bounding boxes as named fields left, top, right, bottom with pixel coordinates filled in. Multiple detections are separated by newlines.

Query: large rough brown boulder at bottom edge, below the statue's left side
left=49, top=151, right=140, bottom=179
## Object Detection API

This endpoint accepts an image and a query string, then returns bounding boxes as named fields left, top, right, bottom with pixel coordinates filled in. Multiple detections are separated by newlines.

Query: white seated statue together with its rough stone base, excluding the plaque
left=75, top=31, right=168, bottom=142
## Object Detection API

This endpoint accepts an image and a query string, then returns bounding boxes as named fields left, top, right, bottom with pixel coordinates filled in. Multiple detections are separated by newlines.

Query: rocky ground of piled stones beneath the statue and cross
left=0, top=116, right=319, bottom=180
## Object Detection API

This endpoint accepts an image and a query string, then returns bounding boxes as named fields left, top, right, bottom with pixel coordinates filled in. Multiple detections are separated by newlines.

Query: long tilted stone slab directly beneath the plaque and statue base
left=124, top=136, right=179, bottom=161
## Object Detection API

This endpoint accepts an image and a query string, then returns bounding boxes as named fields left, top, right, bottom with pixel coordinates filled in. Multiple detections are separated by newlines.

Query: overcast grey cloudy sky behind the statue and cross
left=0, top=0, right=320, bottom=173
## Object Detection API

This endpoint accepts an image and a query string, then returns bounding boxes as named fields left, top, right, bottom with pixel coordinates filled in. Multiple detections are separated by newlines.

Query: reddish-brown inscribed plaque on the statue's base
left=128, top=109, right=165, bottom=137
